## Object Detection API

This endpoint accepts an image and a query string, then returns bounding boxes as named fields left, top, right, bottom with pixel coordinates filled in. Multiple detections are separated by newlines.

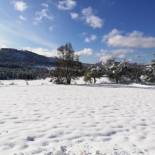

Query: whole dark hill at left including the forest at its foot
left=0, top=48, right=56, bottom=80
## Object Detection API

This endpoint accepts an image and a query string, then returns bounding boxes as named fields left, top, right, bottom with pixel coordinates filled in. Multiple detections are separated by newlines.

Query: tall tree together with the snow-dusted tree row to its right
left=51, top=44, right=155, bottom=84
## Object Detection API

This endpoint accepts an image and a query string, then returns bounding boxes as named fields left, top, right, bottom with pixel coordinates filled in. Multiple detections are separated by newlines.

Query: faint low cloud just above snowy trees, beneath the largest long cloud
left=97, top=49, right=133, bottom=63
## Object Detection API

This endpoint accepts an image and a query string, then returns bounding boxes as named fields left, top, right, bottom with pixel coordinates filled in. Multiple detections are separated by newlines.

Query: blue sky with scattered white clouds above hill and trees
left=0, top=0, right=155, bottom=63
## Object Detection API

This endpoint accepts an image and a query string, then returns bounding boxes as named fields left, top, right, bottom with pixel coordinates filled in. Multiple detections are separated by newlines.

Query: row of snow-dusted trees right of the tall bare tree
left=84, top=60, right=155, bottom=84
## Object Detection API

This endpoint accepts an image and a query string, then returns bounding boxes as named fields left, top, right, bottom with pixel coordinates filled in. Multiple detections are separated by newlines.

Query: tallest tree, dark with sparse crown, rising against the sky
left=54, top=43, right=82, bottom=84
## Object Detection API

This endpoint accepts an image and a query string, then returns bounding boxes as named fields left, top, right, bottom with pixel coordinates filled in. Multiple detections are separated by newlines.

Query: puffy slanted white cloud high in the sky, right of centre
left=82, top=7, right=104, bottom=29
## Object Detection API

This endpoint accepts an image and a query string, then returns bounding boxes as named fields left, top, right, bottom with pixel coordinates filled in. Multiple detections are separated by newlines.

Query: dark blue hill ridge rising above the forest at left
left=0, top=48, right=58, bottom=67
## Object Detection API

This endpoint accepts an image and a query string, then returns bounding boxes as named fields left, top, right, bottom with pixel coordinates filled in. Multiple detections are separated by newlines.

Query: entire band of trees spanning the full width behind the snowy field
left=0, top=43, right=155, bottom=84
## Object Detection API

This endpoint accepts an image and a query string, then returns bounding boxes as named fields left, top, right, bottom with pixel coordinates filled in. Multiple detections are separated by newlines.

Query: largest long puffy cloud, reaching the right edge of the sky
left=102, top=29, right=155, bottom=48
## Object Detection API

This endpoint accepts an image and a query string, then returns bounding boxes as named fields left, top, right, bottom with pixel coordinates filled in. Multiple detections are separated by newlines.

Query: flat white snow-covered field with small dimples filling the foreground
left=0, top=80, right=155, bottom=155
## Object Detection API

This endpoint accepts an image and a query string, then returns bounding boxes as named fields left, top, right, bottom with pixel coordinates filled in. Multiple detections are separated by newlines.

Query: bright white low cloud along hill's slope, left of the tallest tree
left=24, top=47, right=58, bottom=57
